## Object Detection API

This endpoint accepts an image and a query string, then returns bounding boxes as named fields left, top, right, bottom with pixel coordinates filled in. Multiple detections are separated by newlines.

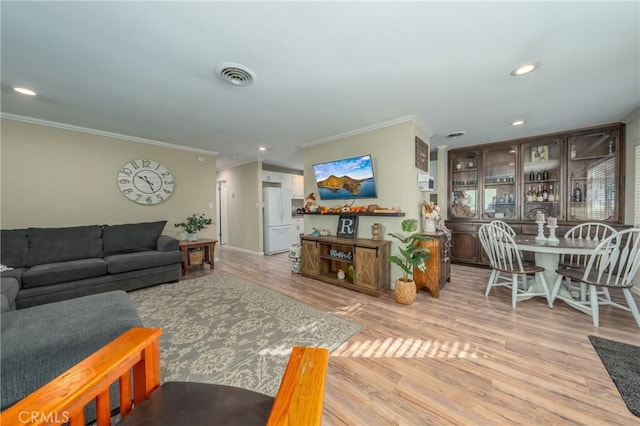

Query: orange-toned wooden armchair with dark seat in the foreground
left=0, top=328, right=329, bottom=426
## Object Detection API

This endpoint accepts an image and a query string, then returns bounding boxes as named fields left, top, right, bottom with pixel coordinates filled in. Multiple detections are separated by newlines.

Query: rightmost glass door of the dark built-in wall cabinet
left=567, top=129, right=622, bottom=222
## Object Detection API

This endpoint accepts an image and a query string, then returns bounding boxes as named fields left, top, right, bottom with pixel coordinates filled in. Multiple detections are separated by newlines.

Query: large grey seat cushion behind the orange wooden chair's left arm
left=0, top=291, right=142, bottom=410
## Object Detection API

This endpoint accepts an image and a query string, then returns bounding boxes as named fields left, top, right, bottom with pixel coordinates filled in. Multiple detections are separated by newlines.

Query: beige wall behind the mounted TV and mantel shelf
left=303, top=121, right=429, bottom=283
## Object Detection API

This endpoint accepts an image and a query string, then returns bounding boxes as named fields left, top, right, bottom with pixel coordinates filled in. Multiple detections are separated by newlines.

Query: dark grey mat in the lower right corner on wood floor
left=589, top=336, right=640, bottom=417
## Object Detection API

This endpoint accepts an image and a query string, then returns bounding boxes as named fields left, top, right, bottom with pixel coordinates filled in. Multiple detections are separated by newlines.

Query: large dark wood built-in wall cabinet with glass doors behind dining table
left=446, top=123, right=628, bottom=265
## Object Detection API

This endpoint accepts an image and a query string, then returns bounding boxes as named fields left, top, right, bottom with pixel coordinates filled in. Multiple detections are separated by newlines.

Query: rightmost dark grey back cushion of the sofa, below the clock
left=102, top=220, right=167, bottom=256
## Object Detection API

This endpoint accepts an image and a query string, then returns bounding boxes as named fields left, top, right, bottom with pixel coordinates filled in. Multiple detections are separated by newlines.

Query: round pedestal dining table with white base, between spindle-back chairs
left=514, top=235, right=600, bottom=314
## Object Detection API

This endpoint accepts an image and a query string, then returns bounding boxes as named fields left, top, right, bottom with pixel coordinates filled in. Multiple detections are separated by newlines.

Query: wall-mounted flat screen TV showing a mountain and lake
left=313, top=155, right=377, bottom=200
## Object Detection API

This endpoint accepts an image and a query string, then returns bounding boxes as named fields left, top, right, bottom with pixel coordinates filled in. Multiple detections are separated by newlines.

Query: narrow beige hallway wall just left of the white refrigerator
left=218, top=161, right=263, bottom=254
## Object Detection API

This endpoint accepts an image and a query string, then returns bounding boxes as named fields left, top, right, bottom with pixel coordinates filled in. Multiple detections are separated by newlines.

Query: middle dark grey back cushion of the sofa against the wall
left=27, top=225, right=102, bottom=267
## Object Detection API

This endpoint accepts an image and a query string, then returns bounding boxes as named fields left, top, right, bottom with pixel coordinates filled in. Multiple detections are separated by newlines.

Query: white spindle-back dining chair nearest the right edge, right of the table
left=551, top=228, right=640, bottom=327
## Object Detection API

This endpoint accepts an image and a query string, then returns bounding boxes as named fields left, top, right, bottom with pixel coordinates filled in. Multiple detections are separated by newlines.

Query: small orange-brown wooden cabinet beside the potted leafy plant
left=413, top=232, right=451, bottom=297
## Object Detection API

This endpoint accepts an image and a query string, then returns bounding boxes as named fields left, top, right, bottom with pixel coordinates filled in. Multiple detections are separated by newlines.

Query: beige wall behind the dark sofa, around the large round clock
left=0, top=119, right=217, bottom=239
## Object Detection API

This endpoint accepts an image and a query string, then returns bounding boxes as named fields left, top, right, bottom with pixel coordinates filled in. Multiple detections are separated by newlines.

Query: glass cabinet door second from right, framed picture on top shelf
left=522, top=138, right=564, bottom=220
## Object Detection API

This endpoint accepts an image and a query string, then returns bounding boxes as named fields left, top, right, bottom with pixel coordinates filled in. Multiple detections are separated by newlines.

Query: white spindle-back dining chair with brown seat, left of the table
left=478, top=224, right=552, bottom=309
